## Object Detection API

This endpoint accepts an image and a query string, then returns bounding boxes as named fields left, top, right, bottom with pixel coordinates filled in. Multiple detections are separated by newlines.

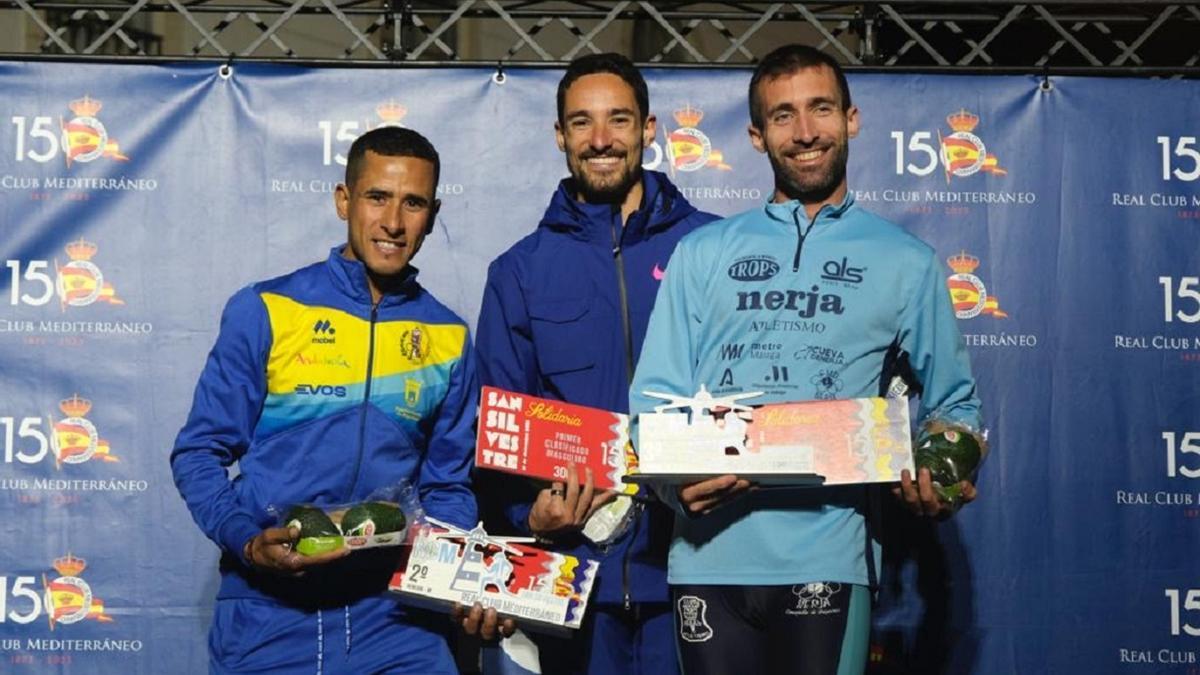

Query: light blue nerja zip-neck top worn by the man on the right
left=630, top=196, right=980, bottom=585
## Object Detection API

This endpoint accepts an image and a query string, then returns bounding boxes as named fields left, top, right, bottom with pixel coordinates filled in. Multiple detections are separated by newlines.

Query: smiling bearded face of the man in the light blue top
left=749, top=66, right=858, bottom=217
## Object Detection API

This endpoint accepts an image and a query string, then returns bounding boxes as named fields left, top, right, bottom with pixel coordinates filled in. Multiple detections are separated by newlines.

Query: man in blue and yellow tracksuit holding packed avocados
left=170, top=127, right=494, bottom=674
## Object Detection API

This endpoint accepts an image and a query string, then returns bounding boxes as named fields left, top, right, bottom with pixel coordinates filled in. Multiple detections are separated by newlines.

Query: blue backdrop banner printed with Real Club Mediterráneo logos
left=0, top=62, right=1200, bottom=675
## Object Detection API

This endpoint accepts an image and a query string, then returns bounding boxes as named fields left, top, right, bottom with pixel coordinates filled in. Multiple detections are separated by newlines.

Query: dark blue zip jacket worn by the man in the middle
left=475, top=172, right=718, bottom=603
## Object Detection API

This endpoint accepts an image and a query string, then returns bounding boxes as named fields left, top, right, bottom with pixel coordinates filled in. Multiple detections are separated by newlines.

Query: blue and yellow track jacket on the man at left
left=170, top=246, right=479, bottom=603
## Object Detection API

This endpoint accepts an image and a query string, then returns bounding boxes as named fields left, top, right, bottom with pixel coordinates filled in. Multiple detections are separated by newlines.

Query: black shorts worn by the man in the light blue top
left=671, top=583, right=871, bottom=675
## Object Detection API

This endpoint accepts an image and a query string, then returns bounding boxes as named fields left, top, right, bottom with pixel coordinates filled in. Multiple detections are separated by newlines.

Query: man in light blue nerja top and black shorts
left=630, top=46, right=980, bottom=675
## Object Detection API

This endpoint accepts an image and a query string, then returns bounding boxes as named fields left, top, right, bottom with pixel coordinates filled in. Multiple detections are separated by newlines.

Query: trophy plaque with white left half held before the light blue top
left=625, top=386, right=913, bottom=485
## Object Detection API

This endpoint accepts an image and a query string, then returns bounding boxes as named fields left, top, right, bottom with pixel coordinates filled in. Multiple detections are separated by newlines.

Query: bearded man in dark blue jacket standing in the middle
left=476, top=54, right=716, bottom=674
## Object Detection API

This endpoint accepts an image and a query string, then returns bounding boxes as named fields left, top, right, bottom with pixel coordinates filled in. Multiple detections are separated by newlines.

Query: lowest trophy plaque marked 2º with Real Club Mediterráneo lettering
left=388, top=519, right=599, bottom=632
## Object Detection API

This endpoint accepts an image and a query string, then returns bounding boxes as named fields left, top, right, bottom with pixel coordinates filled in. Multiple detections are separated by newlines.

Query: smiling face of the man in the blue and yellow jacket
left=334, top=150, right=440, bottom=301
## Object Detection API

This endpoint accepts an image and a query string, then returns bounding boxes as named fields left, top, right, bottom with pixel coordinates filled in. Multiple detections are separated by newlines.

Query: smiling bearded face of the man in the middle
left=554, top=73, right=655, bottom=208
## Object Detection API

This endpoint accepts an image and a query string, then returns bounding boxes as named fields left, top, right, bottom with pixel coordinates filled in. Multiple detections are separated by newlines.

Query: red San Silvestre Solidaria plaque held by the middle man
left=475, top=387, right=636, bottom=492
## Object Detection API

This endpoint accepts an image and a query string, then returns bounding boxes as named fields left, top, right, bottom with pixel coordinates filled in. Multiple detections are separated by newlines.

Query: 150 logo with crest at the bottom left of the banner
left=0, top=554, right=113, bottom=631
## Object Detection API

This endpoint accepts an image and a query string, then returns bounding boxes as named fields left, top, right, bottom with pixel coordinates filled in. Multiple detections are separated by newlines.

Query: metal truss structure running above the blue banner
left=0, top=0, right=1200, bottom=77
